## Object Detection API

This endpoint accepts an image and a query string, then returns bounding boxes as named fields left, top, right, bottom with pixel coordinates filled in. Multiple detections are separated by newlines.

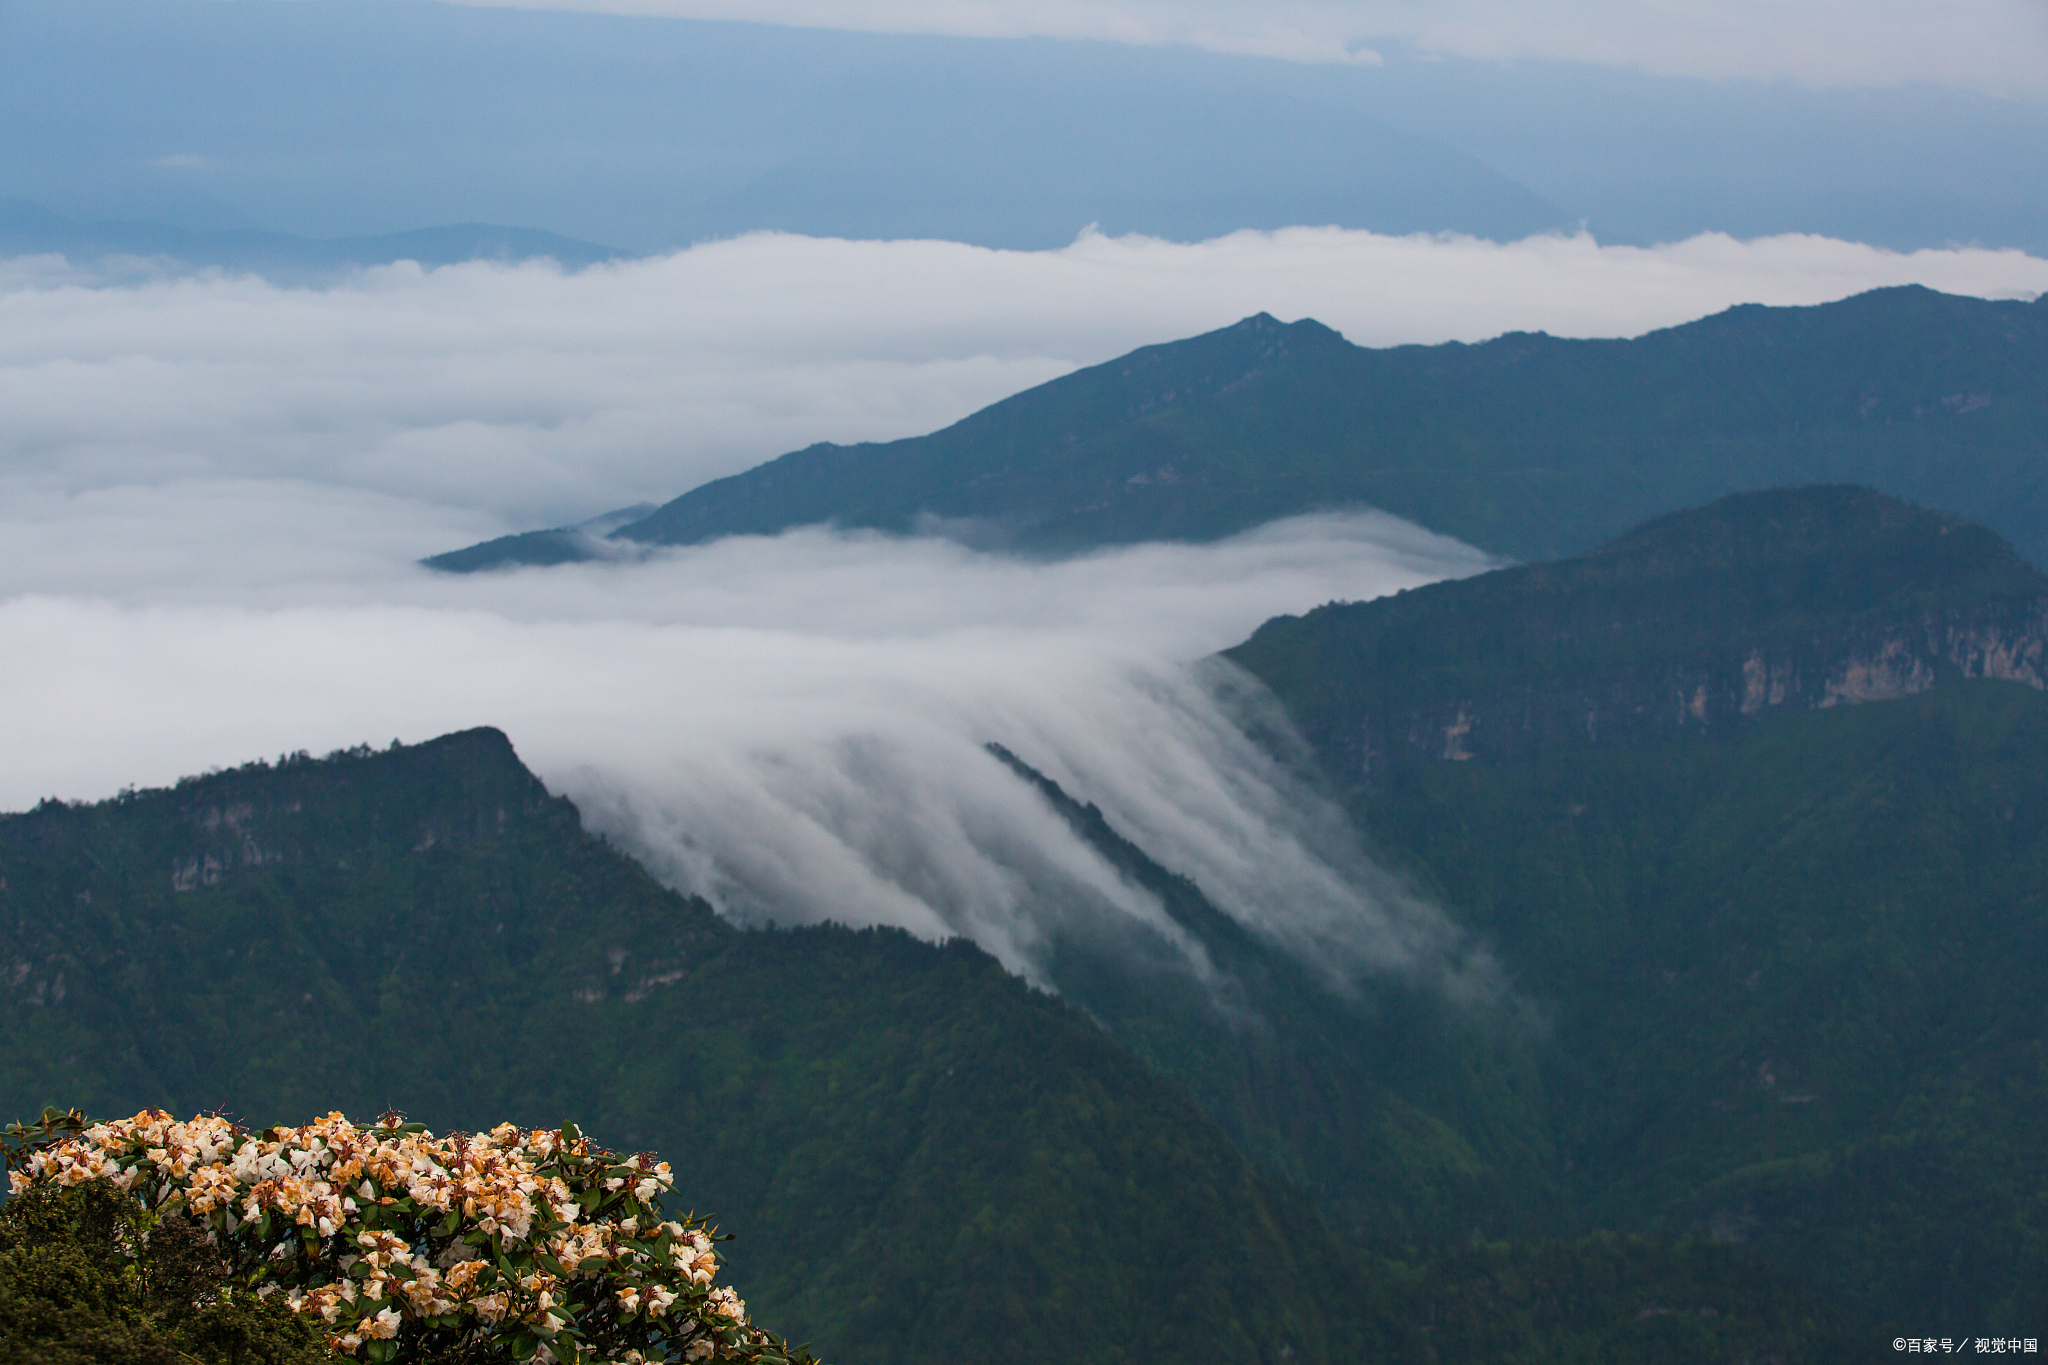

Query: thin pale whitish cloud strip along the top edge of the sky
left=436, top=0, right=2048, bottom=96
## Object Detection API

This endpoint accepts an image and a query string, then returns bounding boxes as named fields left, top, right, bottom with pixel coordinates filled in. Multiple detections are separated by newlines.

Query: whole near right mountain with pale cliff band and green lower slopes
left=1229, top=487, right=2048, bottom=1334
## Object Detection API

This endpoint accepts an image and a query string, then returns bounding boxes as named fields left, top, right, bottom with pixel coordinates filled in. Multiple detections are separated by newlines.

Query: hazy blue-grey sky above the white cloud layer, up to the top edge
left=12, top=0, right=2048, bottom=252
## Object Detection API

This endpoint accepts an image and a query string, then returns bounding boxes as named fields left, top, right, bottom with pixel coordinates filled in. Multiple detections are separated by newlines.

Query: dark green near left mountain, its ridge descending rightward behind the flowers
left=0, top=731, right=1855, bottom=1365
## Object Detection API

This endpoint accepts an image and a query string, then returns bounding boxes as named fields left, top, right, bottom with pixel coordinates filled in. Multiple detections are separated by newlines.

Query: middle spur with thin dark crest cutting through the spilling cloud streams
left=993, top=747, right=1563, bottom=1240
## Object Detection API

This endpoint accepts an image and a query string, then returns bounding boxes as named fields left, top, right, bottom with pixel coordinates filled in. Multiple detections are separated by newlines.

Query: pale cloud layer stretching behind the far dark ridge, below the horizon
left=0, top=227, right=2048, bottom=596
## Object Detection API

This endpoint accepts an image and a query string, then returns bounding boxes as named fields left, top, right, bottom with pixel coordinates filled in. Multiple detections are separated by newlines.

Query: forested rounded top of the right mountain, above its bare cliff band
left=1227, top=487, right=2048, bottom=724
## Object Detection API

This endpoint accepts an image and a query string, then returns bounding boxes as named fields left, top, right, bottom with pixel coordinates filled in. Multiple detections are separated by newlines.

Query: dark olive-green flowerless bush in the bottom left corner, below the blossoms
left=0, top=1181, right=332, bottom=1365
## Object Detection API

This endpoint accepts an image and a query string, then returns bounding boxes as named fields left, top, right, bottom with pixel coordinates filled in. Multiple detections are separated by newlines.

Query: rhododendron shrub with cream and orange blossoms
left=8, top=1109, right=811, bottom=1365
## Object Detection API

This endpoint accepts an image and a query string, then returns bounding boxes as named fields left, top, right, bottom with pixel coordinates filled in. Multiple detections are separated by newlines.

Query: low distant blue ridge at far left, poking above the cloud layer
left=0, top=199, right=623, bottom=284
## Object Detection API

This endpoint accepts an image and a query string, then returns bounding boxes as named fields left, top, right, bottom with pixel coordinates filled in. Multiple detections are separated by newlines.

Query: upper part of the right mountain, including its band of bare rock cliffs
left=1229, top=487, right=2048, bottom=788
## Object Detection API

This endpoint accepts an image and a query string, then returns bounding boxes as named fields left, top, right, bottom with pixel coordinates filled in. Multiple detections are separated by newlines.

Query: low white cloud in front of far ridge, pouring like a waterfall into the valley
left=0, top=514, right=1483, bottom=994
